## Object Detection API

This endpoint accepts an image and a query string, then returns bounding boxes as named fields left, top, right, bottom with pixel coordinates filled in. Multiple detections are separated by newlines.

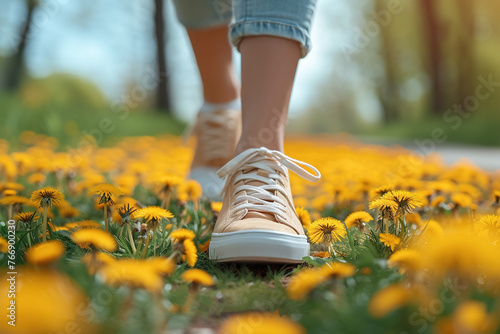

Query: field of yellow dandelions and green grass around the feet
left=0, top=132, right=500, bottom=334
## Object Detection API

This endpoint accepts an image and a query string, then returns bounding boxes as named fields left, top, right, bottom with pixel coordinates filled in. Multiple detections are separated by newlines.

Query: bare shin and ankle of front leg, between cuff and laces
left=235, top=36, right=301, bottom=155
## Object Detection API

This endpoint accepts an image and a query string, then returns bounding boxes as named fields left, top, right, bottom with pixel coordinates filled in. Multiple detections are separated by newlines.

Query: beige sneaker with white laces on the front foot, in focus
left=209, top=147, right=321, bottom=263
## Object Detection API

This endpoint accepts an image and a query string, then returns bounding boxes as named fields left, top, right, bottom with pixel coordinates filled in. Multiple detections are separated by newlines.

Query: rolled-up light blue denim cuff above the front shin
left=229, top=20, right=311, bottom=58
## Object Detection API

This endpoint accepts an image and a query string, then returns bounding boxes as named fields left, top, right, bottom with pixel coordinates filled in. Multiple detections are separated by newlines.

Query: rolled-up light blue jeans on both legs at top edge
left=173, top=0, right=316, bottom=57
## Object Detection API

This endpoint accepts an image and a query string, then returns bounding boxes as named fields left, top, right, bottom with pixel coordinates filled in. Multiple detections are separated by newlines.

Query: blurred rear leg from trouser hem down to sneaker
left=174, top=0, right=241, bottom=200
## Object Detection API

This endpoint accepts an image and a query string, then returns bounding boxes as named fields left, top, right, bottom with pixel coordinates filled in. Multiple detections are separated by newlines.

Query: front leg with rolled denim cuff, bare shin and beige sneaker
left=209, top=0, right=320, bottom=263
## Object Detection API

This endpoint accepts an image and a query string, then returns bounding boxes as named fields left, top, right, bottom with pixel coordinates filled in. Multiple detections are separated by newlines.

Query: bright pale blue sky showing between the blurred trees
left=0, top=0, right=380, bottom=120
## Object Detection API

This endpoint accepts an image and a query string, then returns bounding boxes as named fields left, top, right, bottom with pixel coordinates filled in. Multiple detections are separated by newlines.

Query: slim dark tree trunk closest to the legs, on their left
left=154, top=0, right=170, bottom=113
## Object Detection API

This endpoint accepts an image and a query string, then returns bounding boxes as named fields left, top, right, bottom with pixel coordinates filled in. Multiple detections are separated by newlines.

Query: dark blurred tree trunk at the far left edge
left=4, top=0, right=38, bottom=91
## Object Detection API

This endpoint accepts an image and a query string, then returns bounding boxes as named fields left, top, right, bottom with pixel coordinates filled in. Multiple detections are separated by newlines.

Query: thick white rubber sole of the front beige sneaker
left=209, top=230, right=310, bottom=263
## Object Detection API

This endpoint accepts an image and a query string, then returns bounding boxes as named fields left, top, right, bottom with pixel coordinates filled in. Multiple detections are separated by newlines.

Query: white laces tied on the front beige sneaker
left=217, top=147, right=321, bottom=223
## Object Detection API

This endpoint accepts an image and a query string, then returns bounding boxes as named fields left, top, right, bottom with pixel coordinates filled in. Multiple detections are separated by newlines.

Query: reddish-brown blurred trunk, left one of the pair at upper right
left=420, top=0, right=445, bottom=114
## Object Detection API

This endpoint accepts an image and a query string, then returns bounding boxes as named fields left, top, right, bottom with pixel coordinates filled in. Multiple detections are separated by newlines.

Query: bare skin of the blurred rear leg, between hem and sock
left=187, top=26, right=239, bottom=103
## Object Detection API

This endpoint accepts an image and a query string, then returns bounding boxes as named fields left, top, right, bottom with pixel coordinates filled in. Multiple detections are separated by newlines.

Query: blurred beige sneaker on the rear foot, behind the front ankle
left=189, top=109, right=241, bottom=201
